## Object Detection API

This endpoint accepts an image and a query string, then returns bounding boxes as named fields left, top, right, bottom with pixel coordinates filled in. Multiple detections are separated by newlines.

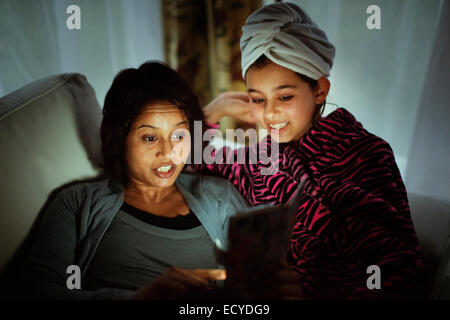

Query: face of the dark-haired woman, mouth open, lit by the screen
left=126, top=102, right=190, bottom=187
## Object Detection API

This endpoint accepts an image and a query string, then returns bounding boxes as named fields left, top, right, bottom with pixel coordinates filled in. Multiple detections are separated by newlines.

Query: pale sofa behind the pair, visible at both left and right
left=0, top=73, right=450, bottom=299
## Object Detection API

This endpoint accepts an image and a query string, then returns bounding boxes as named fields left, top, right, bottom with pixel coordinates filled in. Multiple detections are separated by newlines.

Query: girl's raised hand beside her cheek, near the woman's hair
left=203, top=91, right=255, bottom=123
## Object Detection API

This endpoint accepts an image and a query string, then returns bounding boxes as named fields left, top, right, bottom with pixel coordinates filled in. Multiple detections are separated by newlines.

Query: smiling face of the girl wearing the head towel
left=246, top=62, right=317, bottom=143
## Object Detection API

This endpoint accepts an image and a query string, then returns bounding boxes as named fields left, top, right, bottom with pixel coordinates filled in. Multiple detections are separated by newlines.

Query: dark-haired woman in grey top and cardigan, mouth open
left=13, top=62, right=302, bottom=299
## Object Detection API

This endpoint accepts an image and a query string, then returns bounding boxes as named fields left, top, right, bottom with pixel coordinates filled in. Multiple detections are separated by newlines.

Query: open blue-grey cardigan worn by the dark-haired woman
left=19, top=173, right=249, bottom=299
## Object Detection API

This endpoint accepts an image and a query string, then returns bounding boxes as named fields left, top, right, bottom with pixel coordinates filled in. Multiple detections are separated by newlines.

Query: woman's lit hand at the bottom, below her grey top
left=133, top=267, right=226, bottom=300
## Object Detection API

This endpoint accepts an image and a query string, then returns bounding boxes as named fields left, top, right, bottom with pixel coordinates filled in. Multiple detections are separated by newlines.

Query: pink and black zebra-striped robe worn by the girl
left=194, top=108, right=429, bottom=299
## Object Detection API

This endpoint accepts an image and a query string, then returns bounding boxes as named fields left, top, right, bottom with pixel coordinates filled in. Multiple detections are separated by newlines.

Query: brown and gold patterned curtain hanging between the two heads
left=161, top=0, right=262, bottom=130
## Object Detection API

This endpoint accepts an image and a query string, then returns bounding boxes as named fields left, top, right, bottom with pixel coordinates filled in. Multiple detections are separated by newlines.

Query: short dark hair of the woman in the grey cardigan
left=100, top=61, right=204, bottom=185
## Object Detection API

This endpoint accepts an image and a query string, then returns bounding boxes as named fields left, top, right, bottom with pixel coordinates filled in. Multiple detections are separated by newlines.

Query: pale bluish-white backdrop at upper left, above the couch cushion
left=0, top=0, right=164, bottom=105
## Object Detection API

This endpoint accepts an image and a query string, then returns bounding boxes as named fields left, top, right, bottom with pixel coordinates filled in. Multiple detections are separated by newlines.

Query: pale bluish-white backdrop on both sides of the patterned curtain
left=0, top=0, right=450, bottom=200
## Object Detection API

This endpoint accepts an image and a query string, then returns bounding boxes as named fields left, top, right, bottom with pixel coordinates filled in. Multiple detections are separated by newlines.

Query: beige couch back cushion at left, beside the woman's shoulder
left=0, top=74, right=101, bottom=270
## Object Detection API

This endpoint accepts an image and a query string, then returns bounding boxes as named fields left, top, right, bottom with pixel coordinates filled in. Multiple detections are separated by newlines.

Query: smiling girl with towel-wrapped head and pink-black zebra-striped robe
left=194, top=3, right=429, bottom=299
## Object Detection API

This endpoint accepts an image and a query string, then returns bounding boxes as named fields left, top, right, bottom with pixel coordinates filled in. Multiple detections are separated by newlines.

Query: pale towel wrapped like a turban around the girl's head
left=240, top=2, right=335, bottom=80
